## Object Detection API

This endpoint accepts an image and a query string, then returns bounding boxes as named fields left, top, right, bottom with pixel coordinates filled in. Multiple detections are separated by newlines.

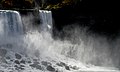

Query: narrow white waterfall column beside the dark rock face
left=39, top=10, right=52, bottom=32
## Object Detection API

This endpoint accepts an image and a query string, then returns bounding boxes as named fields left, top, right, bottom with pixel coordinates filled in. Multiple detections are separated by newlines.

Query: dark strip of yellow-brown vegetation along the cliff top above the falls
left=0, top=0, right=80, bottom=9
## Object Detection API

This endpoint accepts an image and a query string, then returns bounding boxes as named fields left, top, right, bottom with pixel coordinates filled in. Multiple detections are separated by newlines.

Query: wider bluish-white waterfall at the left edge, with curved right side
left=0, top=10, right=23, bottom=35
